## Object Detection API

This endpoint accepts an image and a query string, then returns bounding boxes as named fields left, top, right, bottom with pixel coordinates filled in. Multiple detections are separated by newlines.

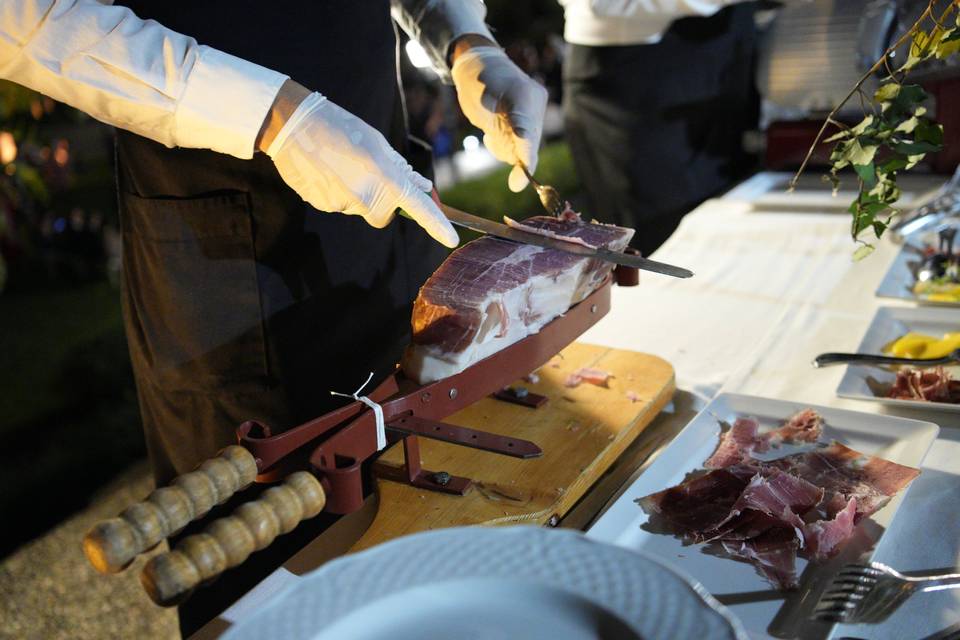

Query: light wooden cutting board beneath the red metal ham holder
left=350, top=343, right=675, bottom=552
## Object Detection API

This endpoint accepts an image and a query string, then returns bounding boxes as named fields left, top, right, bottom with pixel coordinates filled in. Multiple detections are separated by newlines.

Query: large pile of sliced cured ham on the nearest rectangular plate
left=637, top=409, right=920, bottom=589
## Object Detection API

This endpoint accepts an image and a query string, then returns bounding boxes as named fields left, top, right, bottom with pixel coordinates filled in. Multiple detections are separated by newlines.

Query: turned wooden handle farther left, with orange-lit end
left=83, top=445, right=257, bottom=573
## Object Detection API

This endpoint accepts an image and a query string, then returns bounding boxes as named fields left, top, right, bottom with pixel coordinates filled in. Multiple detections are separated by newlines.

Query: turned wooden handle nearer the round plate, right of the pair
left=140, top=471, right=326, bottom=607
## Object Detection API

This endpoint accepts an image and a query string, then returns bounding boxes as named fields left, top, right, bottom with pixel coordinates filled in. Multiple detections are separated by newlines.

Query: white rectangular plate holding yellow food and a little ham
left=837, top=307, right=960, bottom=413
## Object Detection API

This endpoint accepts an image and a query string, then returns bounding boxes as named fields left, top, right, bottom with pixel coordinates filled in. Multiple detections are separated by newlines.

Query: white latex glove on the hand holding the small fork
left=450, top=46, right=547, bottom=191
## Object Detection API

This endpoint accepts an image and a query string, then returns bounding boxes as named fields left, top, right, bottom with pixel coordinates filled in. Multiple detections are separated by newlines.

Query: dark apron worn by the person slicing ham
left=117, top=0, right=445, bottom=635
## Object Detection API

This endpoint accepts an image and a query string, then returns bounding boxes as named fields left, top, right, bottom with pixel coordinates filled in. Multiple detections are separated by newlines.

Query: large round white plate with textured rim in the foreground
left=223, top=527, right=746, bottom=640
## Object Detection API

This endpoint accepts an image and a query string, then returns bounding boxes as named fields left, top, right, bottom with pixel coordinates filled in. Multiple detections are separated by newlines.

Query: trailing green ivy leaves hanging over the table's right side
left=798, top=0, right=960, bottom=255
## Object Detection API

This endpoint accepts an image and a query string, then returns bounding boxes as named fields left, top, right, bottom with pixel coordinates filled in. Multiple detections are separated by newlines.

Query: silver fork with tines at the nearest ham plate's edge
left=813, top=562, right=960, bottom=623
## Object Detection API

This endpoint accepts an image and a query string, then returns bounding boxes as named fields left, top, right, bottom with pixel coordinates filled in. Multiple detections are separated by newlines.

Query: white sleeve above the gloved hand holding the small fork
left=390, top=0, right=496, bottom=84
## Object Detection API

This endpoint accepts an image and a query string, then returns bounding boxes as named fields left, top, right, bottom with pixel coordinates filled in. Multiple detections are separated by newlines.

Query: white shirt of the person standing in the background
left=559, top=0, right=740, bottom=47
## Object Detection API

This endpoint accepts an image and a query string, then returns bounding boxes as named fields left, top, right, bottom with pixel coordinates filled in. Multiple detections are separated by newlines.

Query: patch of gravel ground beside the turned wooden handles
left=0, top=463, right=180, bottom=640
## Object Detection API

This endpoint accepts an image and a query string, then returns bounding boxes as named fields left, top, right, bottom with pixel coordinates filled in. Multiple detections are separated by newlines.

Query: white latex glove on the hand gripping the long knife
left=267, top=93, right=459, bottom=247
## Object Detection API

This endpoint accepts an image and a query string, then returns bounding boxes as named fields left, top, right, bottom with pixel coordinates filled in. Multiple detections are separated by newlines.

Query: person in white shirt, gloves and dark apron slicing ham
left=0, top=0, right=546, bottom=635
